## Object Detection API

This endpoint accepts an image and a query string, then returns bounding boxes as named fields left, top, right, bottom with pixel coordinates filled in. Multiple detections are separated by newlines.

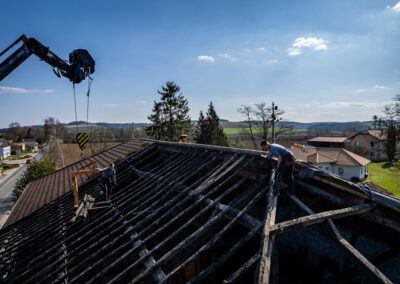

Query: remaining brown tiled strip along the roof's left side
left=3, top=139, right=153, bottom=228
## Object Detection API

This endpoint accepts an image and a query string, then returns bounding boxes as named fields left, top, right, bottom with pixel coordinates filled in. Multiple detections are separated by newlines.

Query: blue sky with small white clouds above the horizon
left=0, top=0, right=400, bottom=127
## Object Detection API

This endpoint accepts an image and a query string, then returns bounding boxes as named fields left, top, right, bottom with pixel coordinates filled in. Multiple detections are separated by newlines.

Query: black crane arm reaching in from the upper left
left=0, top=35, right=95, bottom=83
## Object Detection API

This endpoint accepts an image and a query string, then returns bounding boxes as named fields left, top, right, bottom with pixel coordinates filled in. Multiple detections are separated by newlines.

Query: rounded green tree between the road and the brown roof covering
left=12, top=160, right=56, bottom=203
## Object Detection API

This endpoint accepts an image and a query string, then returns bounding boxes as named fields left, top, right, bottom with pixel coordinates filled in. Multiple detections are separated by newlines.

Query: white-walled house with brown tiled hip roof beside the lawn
left=290, top=146, right=371, bottom=180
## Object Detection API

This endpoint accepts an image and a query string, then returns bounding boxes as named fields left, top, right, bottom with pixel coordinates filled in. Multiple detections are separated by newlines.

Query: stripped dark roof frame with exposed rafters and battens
left=0, top=139, right=400, bottom=283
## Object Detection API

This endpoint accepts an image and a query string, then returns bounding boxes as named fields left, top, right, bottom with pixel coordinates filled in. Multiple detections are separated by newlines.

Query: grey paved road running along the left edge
left=0, top=141, right=55, bottom=227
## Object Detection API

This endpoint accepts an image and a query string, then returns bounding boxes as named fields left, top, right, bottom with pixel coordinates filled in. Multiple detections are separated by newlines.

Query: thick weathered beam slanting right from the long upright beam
left=270, top=203, right=376, bottom=234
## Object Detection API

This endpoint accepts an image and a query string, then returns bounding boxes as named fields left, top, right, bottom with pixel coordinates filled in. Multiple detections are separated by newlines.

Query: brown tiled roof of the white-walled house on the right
left=290, top=146, right=371, bottom=166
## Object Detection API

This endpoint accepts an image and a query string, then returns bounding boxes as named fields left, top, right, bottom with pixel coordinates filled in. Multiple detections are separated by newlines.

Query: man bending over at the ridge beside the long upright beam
left=261, top=140, right=296, bottom=194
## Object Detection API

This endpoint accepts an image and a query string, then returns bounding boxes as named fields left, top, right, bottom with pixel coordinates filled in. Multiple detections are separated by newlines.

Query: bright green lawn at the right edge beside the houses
left=368, top=162, right=400, bottom=198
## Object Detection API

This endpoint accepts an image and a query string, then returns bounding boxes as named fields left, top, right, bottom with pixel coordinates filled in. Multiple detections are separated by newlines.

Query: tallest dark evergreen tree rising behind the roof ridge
left=145, top=82, right=191, bottom=141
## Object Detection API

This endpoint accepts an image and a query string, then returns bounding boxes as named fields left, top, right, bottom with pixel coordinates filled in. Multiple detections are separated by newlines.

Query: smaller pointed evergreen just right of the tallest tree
left=194, top=102, right=229, bottom=146
